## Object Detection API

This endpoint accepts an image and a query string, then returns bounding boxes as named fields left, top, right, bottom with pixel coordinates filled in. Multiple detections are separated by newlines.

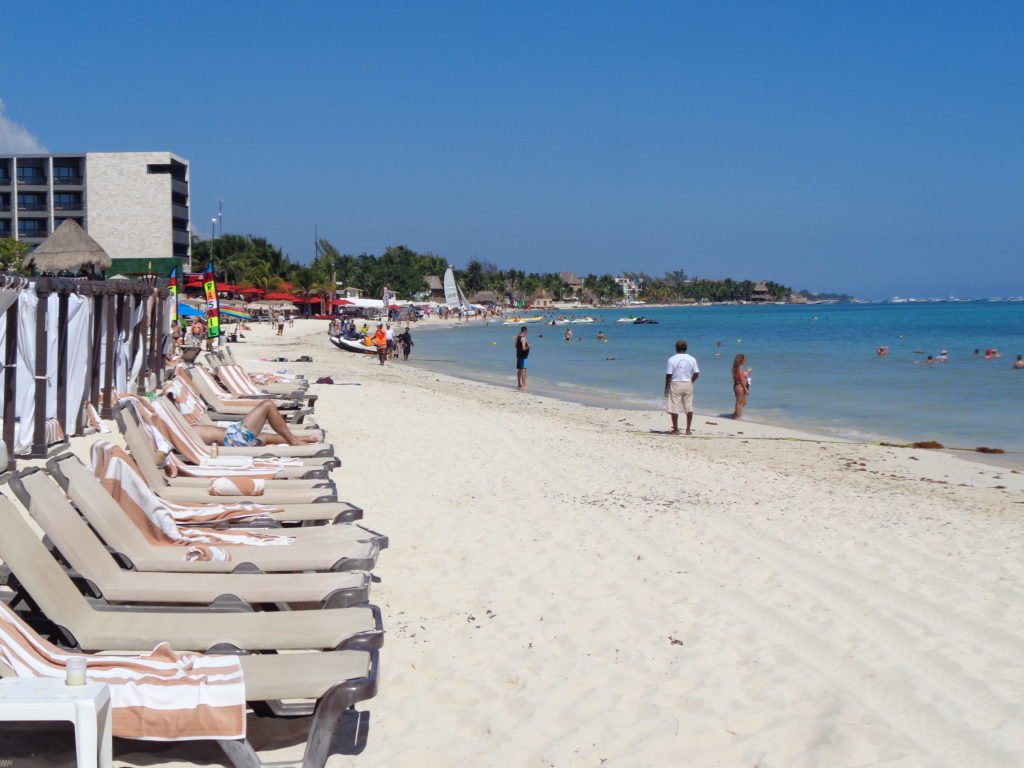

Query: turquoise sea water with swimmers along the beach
left=403, top=302, right=1024, bottom=458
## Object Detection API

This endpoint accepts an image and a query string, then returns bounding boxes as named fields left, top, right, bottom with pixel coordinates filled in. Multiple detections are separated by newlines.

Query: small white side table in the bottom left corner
left=0, top=677, right=112, bottom=768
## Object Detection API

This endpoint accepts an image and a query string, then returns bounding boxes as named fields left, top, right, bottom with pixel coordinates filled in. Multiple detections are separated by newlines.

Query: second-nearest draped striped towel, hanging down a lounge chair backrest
left=93, top=441, right=295, bottom=561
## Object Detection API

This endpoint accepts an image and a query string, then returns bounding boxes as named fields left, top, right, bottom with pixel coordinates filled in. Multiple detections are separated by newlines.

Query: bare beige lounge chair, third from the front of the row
left=12, top=466, right=370, bottom=609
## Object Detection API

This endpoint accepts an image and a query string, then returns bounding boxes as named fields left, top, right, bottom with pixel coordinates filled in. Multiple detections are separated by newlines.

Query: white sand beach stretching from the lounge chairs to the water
left=9, top=321, right=1024, bottom=768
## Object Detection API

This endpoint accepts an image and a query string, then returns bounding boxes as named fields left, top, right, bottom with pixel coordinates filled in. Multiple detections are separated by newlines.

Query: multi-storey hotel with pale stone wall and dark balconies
left=0, top=152, right=191, bottom=274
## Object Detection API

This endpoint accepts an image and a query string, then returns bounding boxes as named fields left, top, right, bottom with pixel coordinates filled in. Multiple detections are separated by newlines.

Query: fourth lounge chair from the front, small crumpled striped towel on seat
left=16, top=461, right=387, bottom=573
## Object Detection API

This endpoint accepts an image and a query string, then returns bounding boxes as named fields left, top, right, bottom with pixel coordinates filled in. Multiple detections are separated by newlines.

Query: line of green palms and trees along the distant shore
left=193, top=234, right=791, bottom=303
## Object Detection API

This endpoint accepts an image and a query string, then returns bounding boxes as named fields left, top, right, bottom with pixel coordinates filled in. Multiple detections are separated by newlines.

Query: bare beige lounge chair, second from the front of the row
left=0, top=495, right=384, bottom=652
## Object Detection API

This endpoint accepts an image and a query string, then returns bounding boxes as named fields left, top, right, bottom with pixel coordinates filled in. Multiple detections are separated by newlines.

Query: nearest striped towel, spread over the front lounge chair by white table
left=0, top=603, right=246, bottom=741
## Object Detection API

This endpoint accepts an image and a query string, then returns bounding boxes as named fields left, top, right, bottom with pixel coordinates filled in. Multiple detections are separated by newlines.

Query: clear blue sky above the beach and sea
left=0, top=0, right=1024, bottom=297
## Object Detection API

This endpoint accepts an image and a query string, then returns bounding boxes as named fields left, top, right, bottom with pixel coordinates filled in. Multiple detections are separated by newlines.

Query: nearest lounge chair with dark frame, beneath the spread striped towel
left=0, top=617, right=380, bottom=768
